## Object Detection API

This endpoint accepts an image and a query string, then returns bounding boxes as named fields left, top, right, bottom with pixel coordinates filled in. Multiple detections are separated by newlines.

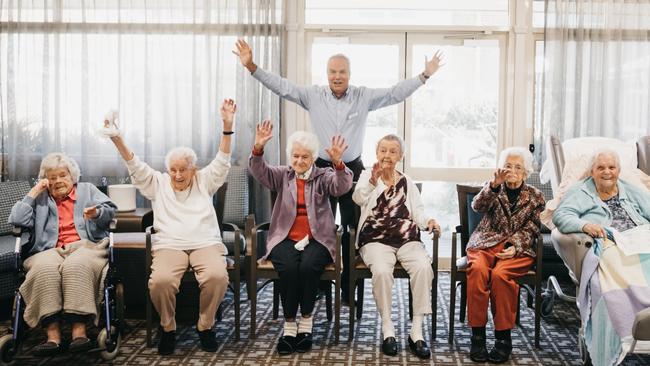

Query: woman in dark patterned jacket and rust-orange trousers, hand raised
left=467, top=147, right=545, bottom=363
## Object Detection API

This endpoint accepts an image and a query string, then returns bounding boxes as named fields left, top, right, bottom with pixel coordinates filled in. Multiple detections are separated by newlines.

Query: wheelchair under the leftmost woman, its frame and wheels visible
left=0, top=220, right=124, bottom=364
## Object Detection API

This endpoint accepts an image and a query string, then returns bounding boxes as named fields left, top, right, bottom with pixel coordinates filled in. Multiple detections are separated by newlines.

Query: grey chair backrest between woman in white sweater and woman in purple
left=215, top=166, right=251, bottom=228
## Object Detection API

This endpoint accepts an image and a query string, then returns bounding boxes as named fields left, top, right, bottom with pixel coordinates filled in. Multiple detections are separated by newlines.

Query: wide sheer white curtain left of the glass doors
left=0, top=0, right=283, bottom=183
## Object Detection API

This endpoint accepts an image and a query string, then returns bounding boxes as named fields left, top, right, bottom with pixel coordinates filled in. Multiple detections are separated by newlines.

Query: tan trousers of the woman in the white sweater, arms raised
left=149, top=245, right=228, bottom=332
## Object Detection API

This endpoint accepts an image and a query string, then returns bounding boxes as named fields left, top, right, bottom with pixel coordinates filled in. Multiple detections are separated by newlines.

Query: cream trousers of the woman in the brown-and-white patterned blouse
left=359, top=241, right=434, bottom=319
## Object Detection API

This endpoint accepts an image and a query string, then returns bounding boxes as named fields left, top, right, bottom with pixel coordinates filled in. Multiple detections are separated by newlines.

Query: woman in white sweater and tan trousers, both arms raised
left=105, top=99, right=236, bottom=355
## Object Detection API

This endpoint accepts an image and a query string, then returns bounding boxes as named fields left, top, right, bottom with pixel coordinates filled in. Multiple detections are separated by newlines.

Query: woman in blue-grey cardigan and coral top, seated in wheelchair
left=9, top=153, right=117, bottom=356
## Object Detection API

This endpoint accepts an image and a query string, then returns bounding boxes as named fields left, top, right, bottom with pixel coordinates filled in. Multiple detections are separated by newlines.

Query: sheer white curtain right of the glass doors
left=536, top=0, right=650, bottom=158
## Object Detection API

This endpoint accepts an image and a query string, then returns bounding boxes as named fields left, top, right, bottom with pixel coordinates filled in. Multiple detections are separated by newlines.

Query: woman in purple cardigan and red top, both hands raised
left=248, top=121, right=352, bottom=355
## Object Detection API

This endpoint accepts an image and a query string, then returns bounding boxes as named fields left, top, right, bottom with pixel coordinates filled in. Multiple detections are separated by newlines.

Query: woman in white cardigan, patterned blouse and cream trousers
left=352, top=134, right=440, bottom=359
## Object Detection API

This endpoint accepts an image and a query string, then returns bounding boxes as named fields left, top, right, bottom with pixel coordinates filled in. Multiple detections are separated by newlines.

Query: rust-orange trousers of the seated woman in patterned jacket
left=467, top=243, right=535, bottom=330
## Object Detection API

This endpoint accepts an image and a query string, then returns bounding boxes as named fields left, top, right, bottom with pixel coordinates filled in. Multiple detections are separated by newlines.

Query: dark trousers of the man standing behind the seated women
left=315, top=157, right=365, bottom=299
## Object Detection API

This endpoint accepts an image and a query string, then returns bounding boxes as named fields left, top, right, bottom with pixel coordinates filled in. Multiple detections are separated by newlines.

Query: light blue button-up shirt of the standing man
left=252, top=67, right=424, bottom=162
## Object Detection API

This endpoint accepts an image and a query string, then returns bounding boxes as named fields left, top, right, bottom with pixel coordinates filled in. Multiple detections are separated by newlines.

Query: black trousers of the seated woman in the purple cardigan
left=269, top=239, right=332, bottom=319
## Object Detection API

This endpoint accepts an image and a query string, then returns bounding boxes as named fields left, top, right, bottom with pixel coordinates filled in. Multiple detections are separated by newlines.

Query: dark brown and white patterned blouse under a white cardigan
left=359, top=176, right=420, bottom=248
